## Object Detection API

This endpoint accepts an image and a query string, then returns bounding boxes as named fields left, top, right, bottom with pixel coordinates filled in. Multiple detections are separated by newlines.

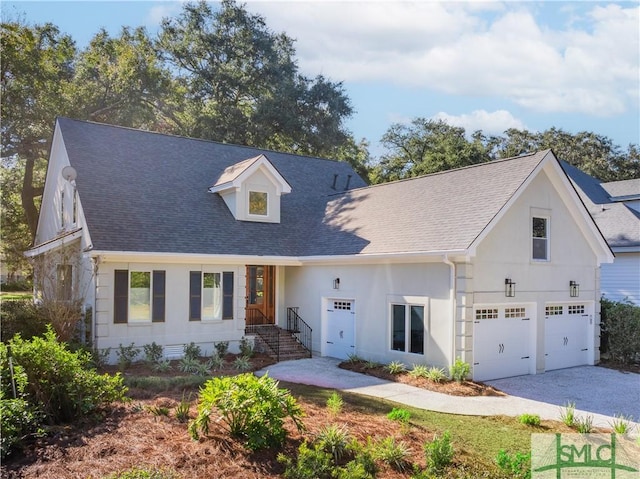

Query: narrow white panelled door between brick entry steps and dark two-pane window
left=322, top=299, right=356, bottom=359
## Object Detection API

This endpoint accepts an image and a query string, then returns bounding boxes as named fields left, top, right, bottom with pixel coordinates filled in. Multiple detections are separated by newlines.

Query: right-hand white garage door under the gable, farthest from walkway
left=544, top=303, right=591, bottom=371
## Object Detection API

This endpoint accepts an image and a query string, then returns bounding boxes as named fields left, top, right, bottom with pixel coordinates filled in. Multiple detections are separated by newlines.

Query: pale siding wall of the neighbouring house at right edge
left=601, top=253, right=640, bottom=306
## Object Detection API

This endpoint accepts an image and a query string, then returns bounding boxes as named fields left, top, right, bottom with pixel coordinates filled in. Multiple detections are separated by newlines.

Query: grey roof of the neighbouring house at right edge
left=561, top=161, right=640, bottom=248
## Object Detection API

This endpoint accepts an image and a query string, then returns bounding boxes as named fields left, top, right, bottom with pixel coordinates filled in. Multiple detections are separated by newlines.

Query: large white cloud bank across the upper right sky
left=247, top=1, right=640, bottom=117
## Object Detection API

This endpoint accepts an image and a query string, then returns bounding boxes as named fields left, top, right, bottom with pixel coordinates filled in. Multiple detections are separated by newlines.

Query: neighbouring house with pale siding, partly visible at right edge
left=562, top=162, right=640, bottom=306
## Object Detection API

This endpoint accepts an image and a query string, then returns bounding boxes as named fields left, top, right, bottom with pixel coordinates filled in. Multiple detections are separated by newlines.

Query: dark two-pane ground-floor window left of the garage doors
left=391, top=304, right=424, bottom=354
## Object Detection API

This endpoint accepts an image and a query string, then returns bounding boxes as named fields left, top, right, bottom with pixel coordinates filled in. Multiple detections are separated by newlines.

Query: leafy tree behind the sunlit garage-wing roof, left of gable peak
left=372, top=118, right=491, bottom=183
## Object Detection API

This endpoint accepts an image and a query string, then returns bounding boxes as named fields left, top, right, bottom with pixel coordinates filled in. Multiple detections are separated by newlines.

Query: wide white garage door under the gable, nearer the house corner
left=473, top=304, right=534, bottom=381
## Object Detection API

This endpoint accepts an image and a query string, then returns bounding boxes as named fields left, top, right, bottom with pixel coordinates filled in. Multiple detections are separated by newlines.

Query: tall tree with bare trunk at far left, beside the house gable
left=0, top=22, right=76, bottom=238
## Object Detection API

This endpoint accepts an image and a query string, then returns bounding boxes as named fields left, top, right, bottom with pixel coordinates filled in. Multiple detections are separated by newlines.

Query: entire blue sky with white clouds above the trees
left=1, top=0, right=640, bottom=156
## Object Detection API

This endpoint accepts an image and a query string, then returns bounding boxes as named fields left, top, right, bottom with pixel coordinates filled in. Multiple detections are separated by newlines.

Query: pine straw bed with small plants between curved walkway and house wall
left=340, top=360, right=506, bottom=396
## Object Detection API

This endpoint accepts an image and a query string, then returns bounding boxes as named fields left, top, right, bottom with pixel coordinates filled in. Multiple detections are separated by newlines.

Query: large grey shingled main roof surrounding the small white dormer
left=58, top=118, right=548, bottom=256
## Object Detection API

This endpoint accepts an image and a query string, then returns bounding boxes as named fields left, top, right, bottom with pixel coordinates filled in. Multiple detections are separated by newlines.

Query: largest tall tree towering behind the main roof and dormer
left=158, top=0, right=352, bottom=156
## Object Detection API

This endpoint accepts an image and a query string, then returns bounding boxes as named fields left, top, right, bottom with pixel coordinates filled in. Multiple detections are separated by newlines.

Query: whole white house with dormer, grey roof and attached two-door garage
left=27, top=118, right=613, bottom=380
